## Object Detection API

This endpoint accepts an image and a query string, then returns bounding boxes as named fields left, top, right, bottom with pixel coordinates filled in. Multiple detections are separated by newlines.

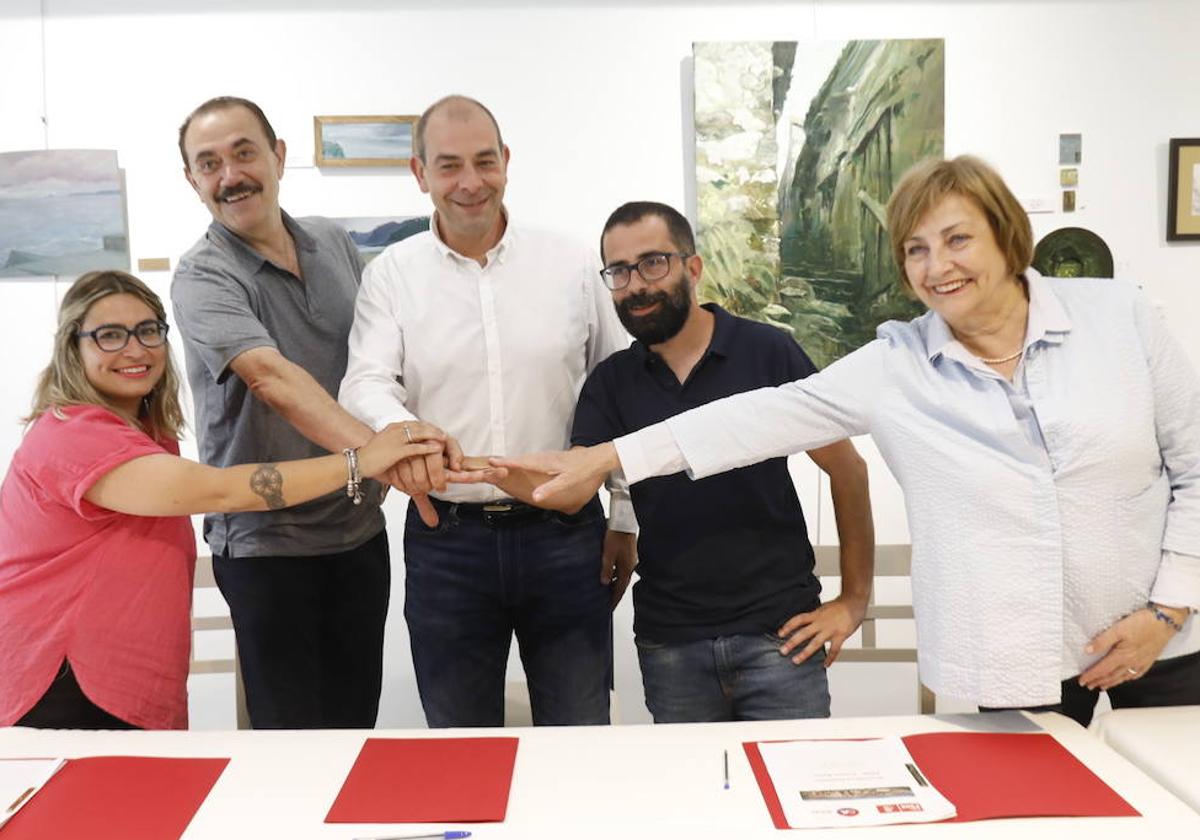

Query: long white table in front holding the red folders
left=0, top=714, right=1200, bottom=840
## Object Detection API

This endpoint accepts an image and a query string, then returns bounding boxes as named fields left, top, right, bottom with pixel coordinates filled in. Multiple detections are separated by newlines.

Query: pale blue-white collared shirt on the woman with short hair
left=616, top=272, right=1200, bottom=706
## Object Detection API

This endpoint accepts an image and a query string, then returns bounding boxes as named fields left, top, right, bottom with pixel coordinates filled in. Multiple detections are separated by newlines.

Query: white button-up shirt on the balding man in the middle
left=338, top=210, right=636, bottom=530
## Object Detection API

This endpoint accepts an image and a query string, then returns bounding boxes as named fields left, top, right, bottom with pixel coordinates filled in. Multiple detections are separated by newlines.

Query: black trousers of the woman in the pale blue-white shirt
left=979, top=653, right=1200, bottom=726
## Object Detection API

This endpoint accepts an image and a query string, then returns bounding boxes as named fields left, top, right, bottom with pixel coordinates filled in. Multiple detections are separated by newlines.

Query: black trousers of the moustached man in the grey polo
left=212, top=532, right=391, bottom=730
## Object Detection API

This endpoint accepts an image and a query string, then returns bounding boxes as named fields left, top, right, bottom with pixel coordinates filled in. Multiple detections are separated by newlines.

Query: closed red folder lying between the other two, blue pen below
left=326, top=738, right=517, bottom=825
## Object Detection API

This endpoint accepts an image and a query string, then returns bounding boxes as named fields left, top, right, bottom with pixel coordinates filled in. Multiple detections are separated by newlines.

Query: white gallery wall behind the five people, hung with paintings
left=0, top=0, right=1200, bottom=725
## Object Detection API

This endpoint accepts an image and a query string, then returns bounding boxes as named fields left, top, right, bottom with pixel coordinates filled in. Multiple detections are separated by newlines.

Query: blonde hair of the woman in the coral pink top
left=25, top=271, right=184, bottom=440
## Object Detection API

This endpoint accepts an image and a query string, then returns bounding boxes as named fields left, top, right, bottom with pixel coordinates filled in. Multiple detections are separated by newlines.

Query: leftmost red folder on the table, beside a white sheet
left=0, top=756, right=229, bottom=840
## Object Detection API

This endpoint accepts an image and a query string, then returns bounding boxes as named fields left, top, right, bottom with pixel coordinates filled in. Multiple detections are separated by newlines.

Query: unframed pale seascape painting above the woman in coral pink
left=0, top=149, right=130, bottom=277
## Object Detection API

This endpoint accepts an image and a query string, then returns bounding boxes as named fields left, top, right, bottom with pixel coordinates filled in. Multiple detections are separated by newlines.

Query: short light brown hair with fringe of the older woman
left=888, top=155, right=1033, bottom=290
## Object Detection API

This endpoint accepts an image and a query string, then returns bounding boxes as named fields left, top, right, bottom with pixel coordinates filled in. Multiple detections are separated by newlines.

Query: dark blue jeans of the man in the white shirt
left=404, top=500, right=612, bottom=727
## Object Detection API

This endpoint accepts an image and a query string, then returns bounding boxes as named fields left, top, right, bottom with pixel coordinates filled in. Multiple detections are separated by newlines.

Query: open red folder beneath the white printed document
left=743, top=732, right=1140, bottom=828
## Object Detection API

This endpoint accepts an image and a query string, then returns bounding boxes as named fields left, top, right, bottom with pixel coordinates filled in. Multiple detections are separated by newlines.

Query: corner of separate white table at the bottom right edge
left=1092, top=706, right=1200, bottom=811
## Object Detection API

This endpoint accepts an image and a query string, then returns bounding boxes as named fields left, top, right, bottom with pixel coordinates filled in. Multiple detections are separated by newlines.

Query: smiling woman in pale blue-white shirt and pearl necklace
left=496, top=157, right=1200, bottom=725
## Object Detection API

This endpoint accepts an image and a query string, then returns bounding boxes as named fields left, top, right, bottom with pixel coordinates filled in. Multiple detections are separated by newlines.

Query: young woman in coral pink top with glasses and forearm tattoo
left=0, top=271, right=451, bottom=728
